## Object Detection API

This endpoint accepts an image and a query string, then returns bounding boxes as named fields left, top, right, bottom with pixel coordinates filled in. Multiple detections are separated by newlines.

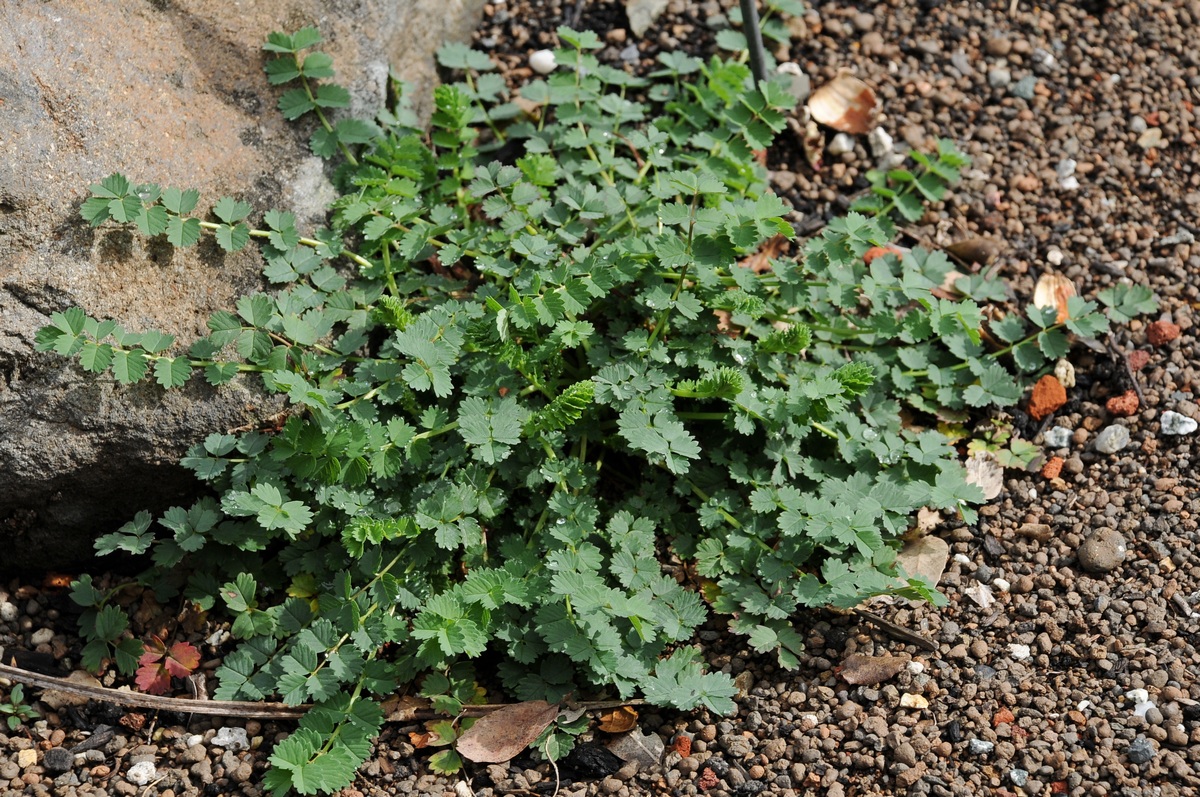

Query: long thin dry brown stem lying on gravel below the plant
left=0, top=664, right=644, bottom=723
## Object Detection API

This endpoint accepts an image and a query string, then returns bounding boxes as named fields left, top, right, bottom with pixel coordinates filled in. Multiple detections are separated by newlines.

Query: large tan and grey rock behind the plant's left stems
left=0, top=0, right=482, bottom=571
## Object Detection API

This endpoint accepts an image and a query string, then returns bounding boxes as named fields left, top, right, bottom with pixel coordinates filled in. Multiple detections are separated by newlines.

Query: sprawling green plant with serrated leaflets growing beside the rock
left=37, top=23, right=1152, bottom=793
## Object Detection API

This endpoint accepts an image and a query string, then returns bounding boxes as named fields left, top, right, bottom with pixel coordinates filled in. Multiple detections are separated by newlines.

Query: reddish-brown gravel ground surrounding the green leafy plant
left=0, top=0, right=1200, bottom=797
